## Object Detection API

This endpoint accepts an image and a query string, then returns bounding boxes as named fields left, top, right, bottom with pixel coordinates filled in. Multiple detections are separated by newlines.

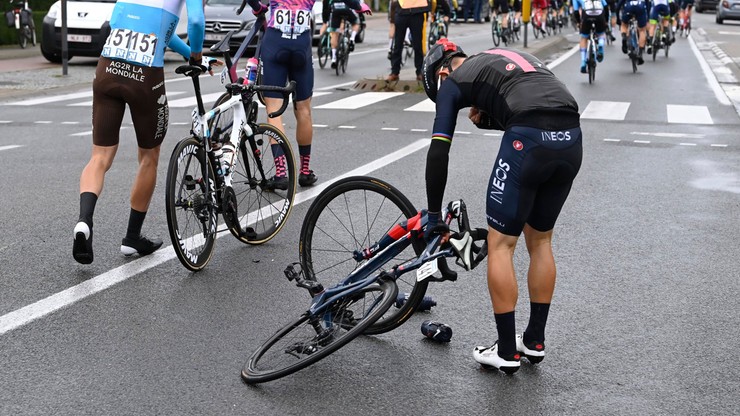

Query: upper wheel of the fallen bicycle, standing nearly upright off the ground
left=299, top=176, right=429, bottom=334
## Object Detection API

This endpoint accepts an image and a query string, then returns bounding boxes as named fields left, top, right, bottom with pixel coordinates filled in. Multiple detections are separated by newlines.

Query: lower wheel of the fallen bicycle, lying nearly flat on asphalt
left=241, top=280, right=398, bottom=384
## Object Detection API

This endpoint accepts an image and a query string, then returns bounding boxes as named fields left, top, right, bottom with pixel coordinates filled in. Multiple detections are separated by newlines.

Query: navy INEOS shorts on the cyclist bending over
left=486, top=127, right=583, bottom=236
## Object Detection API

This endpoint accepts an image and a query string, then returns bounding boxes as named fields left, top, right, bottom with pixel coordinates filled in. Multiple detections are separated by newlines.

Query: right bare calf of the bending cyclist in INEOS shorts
left=524, top=225, right=556, bottom=303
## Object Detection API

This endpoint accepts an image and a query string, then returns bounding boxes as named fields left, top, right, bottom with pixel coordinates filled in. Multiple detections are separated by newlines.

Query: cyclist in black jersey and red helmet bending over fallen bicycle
left=422, top=39, right=582, bottom=373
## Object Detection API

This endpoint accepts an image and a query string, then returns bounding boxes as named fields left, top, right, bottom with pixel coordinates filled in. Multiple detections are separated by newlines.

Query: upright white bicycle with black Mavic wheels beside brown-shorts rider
left=165, top=9, right=296, bottom=271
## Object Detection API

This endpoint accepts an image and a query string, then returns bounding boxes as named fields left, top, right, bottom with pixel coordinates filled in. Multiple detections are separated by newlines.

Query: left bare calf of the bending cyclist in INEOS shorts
left=488, top=227, right=519, bottom=314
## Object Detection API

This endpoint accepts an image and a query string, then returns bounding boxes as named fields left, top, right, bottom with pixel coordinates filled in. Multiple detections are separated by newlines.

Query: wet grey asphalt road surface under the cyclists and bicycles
left=0, top=14, right=740, bottom=415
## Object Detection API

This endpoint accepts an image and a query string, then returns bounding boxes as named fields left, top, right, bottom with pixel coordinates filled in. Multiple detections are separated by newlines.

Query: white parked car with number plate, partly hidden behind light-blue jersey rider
left=41, top=0, right=188, bottom=63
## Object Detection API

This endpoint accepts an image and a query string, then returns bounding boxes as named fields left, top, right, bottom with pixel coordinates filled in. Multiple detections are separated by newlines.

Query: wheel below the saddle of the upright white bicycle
left=165, top=136, right=218, bottom=272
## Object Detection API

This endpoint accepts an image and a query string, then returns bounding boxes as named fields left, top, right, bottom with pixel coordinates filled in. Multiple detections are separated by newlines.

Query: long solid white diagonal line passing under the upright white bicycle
left=0, top=139, right=429, bottom=335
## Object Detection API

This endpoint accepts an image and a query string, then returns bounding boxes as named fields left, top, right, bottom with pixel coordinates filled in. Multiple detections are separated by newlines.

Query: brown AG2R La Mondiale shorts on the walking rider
left=92, top=57, right=169, bottom=149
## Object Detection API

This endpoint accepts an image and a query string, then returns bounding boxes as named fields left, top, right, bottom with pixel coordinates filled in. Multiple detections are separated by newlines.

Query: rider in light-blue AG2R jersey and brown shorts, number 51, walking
left=72, top=0, right=205, bottom=264
